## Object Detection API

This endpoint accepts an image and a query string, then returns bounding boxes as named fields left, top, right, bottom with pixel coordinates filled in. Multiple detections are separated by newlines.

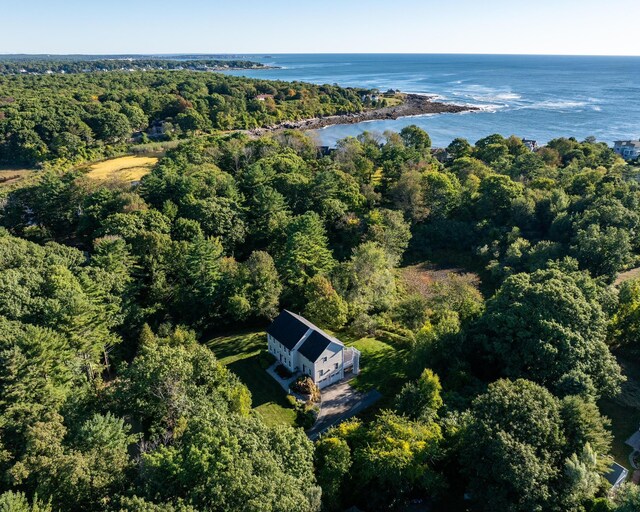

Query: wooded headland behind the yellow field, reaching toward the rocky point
left=0, top=69, right=376, bottom=167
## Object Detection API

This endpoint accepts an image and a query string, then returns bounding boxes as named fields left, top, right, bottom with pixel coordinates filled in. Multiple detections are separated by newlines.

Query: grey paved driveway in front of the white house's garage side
left=307, top=381, right=382, bottom=440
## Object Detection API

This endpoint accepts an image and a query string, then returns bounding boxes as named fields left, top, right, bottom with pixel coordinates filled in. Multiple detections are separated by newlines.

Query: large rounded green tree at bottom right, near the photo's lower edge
left=461, top=379, right=608, bottom=511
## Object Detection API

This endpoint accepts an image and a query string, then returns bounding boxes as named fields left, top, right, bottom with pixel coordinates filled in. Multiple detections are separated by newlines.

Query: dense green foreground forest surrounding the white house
left=0, top=126, right=640, bottom=512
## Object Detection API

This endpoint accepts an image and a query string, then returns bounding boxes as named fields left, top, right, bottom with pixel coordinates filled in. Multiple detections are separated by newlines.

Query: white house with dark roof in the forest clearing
left=267, top=309, right=360, bottom=388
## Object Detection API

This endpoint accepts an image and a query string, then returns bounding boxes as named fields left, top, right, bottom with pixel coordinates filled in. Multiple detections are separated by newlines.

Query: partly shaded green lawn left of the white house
left=206, top=331, right=296, bottom=425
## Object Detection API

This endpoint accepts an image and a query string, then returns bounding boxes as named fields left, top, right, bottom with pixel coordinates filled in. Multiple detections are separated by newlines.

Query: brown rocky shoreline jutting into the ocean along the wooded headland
left=248, top=94, right=479, bottom=136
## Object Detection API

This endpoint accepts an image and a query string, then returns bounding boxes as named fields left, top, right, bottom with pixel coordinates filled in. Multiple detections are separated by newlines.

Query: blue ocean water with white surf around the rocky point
left=224, top=54, right=640, bottom=146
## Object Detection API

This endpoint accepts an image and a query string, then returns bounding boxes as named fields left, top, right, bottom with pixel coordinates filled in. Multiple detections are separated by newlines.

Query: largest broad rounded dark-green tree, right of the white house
left=479, top=263, right=621, bottom=396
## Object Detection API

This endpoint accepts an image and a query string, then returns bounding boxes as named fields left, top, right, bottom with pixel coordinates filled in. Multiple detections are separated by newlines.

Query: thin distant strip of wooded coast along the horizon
left=0, top=57, right=264, bottom=75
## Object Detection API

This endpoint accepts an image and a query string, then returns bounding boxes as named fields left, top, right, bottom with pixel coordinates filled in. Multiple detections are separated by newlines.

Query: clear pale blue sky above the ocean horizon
left=0, top=0, right=640, bottom=55
